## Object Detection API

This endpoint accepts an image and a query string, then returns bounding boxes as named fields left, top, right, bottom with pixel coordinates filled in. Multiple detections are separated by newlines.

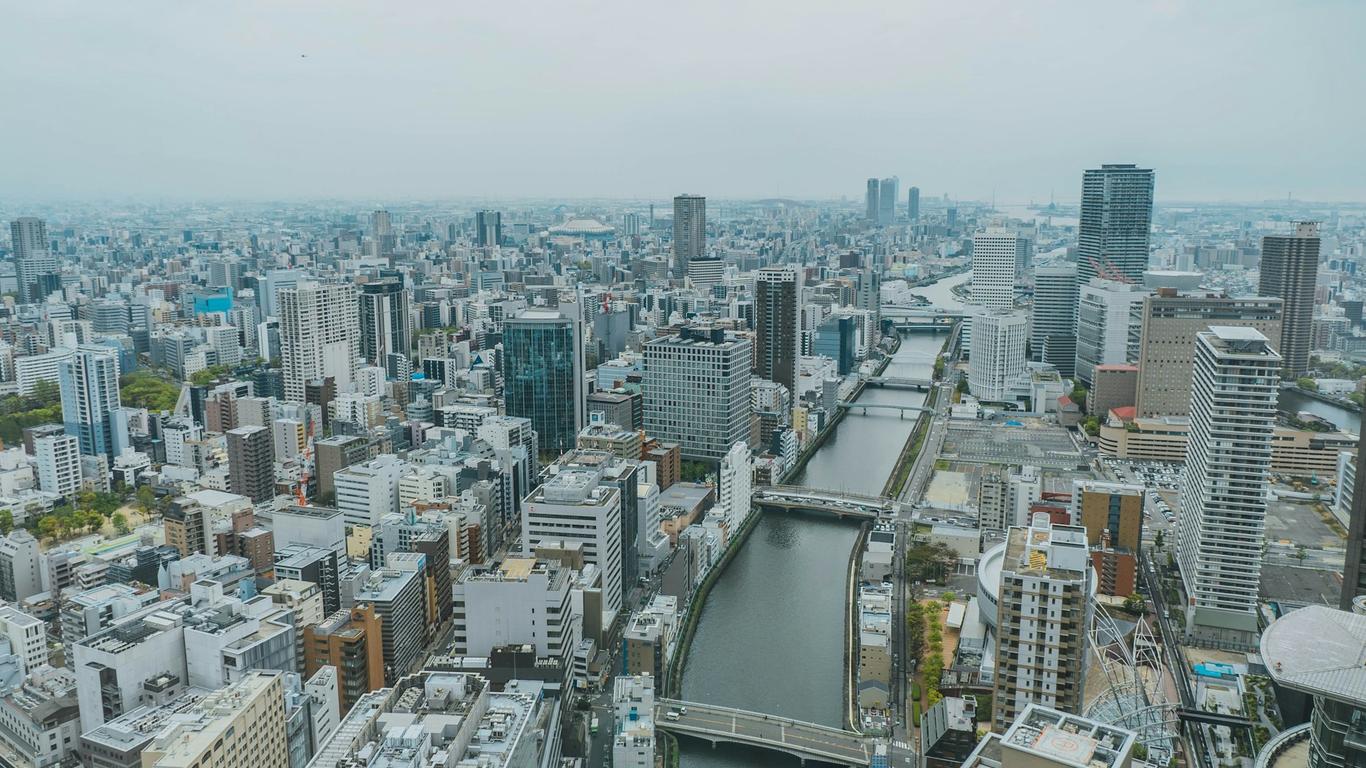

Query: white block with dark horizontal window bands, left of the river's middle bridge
left=522, top=466, right=623, bottom=617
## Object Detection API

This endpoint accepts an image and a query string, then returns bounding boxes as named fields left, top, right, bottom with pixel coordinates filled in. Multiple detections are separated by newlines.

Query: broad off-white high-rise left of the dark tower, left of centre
left=279, top=283, right=361, bottom=403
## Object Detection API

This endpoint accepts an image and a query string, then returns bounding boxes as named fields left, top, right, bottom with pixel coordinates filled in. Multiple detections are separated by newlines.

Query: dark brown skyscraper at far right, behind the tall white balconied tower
left=1257, top=221, right=1318, bottom=379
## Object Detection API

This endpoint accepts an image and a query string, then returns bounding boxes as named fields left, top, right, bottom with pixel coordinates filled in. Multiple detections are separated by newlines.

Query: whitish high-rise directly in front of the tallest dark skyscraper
left=1074, top=279, right=1146, bottom=387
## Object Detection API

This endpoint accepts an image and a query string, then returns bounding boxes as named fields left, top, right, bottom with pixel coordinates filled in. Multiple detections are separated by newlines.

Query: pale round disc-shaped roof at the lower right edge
left=1261, top=605, right=1366, bottom=705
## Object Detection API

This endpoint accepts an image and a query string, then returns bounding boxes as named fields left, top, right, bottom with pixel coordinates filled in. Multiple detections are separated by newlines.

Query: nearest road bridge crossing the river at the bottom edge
left=654, top=698, right=873, bottom=765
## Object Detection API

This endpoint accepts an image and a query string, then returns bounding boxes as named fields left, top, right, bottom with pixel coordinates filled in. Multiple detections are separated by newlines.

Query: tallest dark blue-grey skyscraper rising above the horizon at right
left=1076, top=164, right=1153, bottom=286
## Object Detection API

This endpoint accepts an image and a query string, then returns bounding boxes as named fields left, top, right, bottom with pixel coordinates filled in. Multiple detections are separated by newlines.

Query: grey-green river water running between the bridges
left=680, top=275, right=967, bottom=768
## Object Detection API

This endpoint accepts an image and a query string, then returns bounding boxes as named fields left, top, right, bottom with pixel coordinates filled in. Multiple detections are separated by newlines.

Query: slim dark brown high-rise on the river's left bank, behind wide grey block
left=754, top=265, right=802, bottom=398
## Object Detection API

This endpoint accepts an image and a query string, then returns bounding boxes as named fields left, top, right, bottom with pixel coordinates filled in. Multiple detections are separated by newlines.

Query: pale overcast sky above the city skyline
left=0, top=0, right=1366, bottom=202
